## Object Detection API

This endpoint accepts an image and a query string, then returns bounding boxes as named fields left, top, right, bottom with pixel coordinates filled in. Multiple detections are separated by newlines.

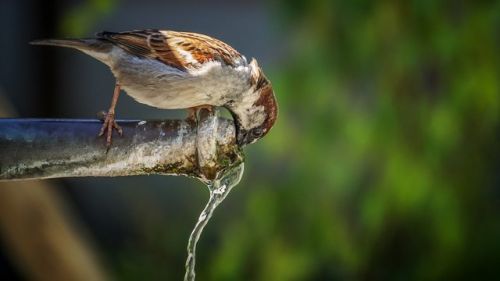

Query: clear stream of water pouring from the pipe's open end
left=184, top=162, right=244, bottom=281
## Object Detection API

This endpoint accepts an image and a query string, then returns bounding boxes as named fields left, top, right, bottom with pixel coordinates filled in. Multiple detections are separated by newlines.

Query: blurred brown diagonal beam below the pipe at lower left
left=0, top=181, right=110, bottom=281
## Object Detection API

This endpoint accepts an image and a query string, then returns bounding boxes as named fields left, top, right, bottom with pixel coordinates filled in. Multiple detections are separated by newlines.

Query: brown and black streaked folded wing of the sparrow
left=97, top=29, right=246, bottom=70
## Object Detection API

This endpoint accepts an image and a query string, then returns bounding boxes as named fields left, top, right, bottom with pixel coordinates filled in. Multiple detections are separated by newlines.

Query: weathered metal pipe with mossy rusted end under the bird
left=0, top=112, right=243, bottom=182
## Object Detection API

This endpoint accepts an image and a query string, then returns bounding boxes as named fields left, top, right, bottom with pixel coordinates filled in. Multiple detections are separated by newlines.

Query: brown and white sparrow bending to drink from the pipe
left=31, top=29, right=278, bottom=148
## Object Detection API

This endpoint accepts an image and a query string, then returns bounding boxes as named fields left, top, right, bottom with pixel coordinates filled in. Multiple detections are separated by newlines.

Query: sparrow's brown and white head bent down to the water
left=229, top=59, right=278, bottom=146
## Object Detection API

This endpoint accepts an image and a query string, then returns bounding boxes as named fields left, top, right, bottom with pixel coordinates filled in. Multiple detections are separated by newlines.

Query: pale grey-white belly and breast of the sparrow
left=105, top=47, right=254, bottom=109
